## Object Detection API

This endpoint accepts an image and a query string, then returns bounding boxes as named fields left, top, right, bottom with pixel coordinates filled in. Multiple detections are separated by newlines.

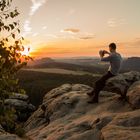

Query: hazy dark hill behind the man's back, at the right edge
left=122, top=57, right=140, bottom=71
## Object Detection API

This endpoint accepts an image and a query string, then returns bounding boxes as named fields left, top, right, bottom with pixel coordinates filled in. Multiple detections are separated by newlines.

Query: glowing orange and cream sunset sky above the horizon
left=13, top=0, right=140, bottom=58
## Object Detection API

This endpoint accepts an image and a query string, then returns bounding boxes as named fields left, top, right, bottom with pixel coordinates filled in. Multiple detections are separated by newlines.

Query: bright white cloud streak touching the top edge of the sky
left=29, top=0, right=47, bottom=16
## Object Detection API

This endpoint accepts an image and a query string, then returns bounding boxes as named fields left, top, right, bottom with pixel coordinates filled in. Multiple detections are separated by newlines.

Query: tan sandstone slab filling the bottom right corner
left=102, top=110, right=140, bottom=140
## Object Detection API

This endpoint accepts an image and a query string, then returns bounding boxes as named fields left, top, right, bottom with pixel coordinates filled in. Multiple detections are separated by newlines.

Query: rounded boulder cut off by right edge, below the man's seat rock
left=127, top=81, right=140, bottom=109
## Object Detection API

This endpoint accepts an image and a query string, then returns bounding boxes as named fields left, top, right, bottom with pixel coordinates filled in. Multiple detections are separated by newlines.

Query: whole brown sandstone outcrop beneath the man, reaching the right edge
left=24, top=72, right=140, bottom=140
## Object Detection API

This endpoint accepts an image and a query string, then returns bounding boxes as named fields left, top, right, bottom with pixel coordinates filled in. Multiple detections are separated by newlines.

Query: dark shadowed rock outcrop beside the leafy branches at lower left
left=5, top=93, right=35, bottom=121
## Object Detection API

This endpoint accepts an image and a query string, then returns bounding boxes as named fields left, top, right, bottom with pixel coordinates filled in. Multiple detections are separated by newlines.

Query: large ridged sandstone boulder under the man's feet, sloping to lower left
left=24, top=84, right=135, bottom=140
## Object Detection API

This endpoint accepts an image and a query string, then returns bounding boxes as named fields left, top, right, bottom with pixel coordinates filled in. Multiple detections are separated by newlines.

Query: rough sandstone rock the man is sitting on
left=104, top=71, right=140, bottom=96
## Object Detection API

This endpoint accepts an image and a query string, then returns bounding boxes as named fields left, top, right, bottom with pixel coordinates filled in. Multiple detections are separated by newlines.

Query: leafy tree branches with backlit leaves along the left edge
left=0, top=0, right=30, bottom=135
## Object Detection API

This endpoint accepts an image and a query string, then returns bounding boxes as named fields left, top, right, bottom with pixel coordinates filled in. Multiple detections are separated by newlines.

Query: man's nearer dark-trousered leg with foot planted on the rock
left=88, top=71, right=114, bottom=103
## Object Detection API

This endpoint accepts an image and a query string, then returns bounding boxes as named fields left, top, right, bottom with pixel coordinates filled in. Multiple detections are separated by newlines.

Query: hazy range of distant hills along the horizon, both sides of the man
left=28, top=57, right=140, bottom=74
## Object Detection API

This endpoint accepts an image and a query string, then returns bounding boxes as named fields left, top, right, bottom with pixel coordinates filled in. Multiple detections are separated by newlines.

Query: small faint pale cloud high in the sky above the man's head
left=107, top=18, right=127, bottom=28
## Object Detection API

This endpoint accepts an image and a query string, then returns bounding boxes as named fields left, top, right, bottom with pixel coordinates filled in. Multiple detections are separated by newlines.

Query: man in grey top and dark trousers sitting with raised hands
left=87, top=43, right=122, bottom=103
